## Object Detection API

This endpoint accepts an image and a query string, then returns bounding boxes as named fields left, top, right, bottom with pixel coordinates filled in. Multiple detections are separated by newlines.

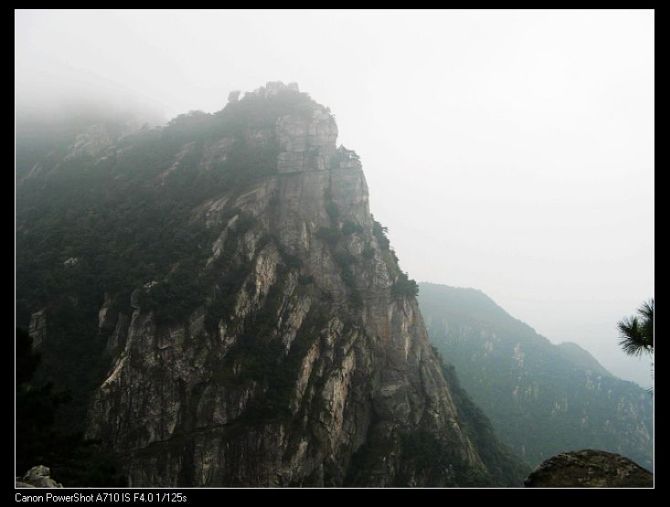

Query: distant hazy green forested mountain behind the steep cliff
left=419, top=283, right=653, bottom=469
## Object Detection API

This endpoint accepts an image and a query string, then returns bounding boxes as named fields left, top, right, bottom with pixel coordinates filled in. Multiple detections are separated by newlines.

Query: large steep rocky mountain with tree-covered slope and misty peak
left=16, top=82, right=528, bottom=486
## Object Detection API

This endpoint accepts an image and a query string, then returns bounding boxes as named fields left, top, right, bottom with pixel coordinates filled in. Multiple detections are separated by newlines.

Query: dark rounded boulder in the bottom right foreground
left=525, top=449, right=654, bottom=488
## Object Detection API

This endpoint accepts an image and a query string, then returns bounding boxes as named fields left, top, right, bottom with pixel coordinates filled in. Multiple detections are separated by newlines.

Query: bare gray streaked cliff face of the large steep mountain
left=82, top=85, right=516, bottom=486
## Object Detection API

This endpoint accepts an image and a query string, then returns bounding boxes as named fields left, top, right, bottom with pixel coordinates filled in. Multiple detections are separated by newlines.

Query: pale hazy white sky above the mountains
left=16, top=10, right=654, bottom=385
